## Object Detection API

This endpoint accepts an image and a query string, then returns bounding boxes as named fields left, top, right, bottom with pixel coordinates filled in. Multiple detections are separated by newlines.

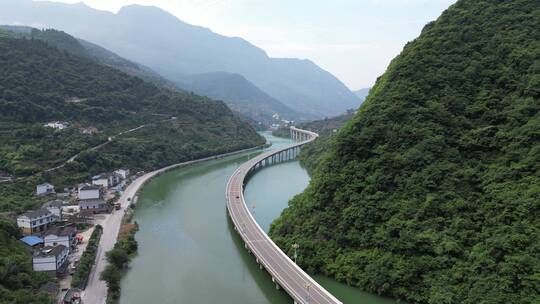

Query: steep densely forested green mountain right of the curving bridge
left=270, top=0, right=540, bottom=304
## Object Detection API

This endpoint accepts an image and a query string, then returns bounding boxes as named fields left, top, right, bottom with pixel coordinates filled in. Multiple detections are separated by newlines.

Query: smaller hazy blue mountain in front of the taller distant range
left=178, top=72, right=309, bottom=124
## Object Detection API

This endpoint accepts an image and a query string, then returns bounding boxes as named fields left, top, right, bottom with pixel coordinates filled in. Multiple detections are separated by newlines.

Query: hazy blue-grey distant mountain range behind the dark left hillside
left=0, top=0, right=360, bottom=118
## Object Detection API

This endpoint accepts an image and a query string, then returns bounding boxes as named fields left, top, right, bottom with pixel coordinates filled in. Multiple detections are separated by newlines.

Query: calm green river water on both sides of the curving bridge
left=120, top=133, right=395, bottom=304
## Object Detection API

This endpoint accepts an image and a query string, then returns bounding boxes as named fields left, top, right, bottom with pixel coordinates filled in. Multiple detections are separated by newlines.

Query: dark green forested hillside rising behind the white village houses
left=0, top=32, right=264, bottom=210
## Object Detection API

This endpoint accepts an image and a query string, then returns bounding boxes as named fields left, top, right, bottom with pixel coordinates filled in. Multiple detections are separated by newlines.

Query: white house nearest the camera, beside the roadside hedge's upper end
left=32, top=245, right=68, bottom=275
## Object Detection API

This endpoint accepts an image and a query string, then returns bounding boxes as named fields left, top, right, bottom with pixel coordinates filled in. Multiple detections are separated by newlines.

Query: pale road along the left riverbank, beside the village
left=82, top=144, right=267, bottom=304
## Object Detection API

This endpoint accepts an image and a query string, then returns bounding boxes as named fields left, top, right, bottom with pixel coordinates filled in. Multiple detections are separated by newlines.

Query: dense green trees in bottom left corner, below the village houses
left=0, top=220, right=54, bottom=304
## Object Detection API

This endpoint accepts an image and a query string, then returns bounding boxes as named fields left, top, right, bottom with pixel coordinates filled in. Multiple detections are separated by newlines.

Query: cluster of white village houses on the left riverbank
left=17, top=169, right=129, bottom=275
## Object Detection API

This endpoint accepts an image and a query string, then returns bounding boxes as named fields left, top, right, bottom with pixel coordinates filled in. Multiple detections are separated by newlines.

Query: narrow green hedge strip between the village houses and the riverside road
left=71, top=225, right=103, bottom=289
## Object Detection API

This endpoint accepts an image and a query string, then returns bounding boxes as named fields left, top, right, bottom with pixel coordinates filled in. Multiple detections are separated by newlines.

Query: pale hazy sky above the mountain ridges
left=43, top=0, right=456, bottom=89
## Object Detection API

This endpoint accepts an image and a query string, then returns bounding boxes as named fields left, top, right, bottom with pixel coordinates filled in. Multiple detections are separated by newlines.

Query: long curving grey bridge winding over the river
left=226, top=129, right=341, bottom=304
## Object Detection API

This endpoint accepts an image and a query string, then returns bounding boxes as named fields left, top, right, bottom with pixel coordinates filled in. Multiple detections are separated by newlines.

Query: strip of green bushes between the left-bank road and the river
left=100, top=222, right=139, bottom=303
